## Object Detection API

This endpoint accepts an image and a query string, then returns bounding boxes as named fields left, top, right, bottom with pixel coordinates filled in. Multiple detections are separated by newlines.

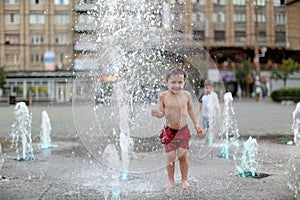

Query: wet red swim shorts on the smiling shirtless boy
left=164, top=125, right=191, bottom=153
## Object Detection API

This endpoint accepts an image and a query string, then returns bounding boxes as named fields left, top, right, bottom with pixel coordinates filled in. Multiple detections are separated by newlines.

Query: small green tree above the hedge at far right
left=272, top=58, right=300, bottom=88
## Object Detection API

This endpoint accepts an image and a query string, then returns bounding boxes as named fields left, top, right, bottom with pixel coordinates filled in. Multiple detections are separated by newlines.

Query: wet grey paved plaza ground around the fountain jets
left=0, top=99, right=300, bottom=200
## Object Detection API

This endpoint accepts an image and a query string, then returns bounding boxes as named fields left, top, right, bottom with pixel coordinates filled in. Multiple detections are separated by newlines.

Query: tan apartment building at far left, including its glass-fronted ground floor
left=0, top=0, right=73, bottom=101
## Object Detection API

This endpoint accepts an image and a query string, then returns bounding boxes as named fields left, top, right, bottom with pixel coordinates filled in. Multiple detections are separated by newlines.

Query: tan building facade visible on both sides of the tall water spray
left=0, top=0, right=300, bottom=101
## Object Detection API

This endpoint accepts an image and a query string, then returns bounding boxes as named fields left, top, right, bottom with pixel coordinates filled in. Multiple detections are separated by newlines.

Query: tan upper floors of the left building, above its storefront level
left=0, top=0, right=73, bottom=71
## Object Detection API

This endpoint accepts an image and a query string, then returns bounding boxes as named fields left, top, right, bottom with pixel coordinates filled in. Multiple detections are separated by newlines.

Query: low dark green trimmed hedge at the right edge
left=271, top=88, right=300, bottom=103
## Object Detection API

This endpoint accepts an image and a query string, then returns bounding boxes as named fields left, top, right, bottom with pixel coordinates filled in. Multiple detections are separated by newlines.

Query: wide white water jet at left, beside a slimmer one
left=11, top=102, right=34, bottom=160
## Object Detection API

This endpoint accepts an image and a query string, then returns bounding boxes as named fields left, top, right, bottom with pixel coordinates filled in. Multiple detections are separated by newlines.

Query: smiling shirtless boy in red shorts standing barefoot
left=151, top=67, right=202, bottom=189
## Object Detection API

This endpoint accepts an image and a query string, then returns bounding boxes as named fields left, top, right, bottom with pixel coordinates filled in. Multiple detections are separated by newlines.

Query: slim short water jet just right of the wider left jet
left=40, top=110, right=52, bottom=149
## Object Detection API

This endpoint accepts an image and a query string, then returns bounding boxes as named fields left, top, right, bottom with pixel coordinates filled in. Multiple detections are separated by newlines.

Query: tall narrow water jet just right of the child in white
left=220, top=92, right=240, bottom=158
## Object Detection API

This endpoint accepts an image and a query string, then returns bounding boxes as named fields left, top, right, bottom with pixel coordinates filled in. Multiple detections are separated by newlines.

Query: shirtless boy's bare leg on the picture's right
left=178, top=148, right=190, bottom=189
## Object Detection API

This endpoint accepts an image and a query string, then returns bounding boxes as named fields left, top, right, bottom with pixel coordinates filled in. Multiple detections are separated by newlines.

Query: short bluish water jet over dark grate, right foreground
left=234, top=136, right=258, bottom=177
